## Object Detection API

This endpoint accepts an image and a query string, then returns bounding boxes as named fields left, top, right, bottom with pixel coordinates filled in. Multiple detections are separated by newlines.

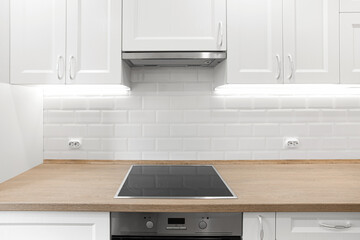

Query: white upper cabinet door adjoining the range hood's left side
left=66, top=0, right=122, bottom=84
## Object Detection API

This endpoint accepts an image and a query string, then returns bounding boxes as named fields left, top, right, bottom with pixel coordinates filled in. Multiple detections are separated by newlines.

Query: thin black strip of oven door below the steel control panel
left=111, top=236, right=241, bottom=240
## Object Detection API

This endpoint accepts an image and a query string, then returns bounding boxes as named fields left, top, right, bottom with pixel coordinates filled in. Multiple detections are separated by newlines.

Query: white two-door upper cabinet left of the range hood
left=11, top=0, right=129, bottom=84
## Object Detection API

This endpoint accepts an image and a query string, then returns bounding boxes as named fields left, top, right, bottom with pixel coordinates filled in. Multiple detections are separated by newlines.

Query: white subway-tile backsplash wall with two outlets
left=44, top=68, right=360, bottom=160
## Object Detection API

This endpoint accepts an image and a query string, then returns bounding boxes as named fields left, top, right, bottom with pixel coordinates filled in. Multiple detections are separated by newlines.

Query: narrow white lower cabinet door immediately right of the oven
left=243, top=212, right=275, bottom=240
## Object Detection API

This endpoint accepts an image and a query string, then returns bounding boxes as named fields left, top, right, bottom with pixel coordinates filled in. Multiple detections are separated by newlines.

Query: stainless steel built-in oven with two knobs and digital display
left=111, top=213, right=242, bottom=240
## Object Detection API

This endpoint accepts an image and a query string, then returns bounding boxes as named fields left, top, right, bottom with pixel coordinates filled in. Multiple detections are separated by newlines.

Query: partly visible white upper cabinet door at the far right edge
left=340, top=13, right=360, bottom=84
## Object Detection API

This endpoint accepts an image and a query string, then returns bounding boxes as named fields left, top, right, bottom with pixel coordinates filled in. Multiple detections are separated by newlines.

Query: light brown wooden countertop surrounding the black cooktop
left=0, top=161, right=360, bottom=212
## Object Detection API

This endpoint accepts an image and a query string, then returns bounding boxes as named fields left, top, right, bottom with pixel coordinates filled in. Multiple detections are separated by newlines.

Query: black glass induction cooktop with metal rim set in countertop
left=115, top=165, right=237, bottom=199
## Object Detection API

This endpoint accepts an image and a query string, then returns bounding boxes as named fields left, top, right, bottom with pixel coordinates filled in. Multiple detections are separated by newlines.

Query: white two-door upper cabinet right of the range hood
left=217, top=0, right=339, bottom=85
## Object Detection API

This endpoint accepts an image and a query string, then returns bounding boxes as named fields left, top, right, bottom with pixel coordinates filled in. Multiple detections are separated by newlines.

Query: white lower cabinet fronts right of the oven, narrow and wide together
left=243, top=212, right=360, bottom=240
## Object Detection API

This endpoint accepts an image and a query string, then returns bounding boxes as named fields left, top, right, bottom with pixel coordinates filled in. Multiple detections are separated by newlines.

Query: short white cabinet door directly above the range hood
left=123, top=0, right=226, bottom=51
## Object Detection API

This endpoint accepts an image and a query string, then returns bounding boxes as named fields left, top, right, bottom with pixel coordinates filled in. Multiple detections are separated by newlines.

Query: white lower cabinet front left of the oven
left=0, top=212, right=110, bottom=240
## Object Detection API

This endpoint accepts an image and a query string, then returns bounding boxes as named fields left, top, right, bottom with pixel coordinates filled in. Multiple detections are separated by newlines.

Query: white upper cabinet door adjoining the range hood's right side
left=227, top=0, right=288, bottom=83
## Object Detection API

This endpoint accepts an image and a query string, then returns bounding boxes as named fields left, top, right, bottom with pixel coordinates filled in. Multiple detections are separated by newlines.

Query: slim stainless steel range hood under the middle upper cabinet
left=122, top=52, right=226, bottom=67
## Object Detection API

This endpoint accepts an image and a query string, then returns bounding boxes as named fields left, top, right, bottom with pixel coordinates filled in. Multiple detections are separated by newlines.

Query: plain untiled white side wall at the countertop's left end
left=0, top=84, right=43, bottom=183
